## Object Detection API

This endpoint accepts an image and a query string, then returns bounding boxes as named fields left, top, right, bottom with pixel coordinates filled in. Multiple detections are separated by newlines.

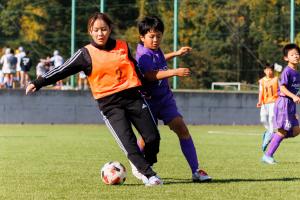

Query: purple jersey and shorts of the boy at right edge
left=273, top=66, right=300, bottom=132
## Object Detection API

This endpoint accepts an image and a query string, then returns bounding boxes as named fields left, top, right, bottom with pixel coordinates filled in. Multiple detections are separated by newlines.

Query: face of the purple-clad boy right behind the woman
left=140, top=30, right=163, bottom=50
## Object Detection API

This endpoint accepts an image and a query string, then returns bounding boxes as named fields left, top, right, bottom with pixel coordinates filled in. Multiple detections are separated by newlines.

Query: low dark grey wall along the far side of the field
left=0, top=90, right=259, bottom=124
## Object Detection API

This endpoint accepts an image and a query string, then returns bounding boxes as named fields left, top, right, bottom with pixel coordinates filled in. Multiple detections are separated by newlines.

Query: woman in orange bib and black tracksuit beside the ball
left=26, top=12, right=163, bottom=186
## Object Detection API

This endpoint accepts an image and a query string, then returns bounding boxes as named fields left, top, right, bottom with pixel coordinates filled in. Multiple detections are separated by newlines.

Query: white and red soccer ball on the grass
left=101, top=161, right=126, bottom=185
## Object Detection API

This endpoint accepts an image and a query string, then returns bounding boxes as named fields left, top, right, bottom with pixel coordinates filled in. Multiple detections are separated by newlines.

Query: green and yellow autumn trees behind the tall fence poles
left=0, top=0, right=300, bottom=89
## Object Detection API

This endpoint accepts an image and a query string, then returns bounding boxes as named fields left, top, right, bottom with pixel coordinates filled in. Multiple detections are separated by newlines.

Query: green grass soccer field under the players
left=0, top=125, right=300, bottom=200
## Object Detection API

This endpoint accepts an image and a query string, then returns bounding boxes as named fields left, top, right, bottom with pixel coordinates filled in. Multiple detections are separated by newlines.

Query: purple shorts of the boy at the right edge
left=273, top=97, right=299, bottom=131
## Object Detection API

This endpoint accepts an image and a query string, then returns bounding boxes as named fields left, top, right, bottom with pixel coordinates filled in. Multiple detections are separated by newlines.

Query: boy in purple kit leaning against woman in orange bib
left=132, top=16, right=211, bottom=182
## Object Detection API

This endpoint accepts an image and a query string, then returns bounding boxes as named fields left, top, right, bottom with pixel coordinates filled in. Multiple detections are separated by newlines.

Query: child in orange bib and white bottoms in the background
left=257, top=63, right=278, bottom=152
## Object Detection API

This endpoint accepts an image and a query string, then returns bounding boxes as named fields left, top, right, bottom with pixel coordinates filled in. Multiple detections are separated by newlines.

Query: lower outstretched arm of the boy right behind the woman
left=144, top=68, right=190, bottom=81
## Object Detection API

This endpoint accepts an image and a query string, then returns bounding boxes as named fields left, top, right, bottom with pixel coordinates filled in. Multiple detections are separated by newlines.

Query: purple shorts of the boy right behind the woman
left=148, top=95, right=182, bottom=125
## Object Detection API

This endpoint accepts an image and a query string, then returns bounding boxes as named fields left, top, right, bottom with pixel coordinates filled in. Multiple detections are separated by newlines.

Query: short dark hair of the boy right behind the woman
left=138, top=16, right=165, bottom=36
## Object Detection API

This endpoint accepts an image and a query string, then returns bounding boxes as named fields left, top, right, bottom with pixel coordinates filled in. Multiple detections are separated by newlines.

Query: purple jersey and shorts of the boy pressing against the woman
left=136, top=44, right=181, bottom=124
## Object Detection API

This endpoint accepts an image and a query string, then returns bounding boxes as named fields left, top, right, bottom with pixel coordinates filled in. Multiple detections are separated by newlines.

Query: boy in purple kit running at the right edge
left=262, top=44, right=300, bottom=164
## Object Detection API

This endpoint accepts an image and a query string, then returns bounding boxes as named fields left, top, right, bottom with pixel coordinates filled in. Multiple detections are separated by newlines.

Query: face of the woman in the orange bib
left=89, top=19, right=111, bottom=47
